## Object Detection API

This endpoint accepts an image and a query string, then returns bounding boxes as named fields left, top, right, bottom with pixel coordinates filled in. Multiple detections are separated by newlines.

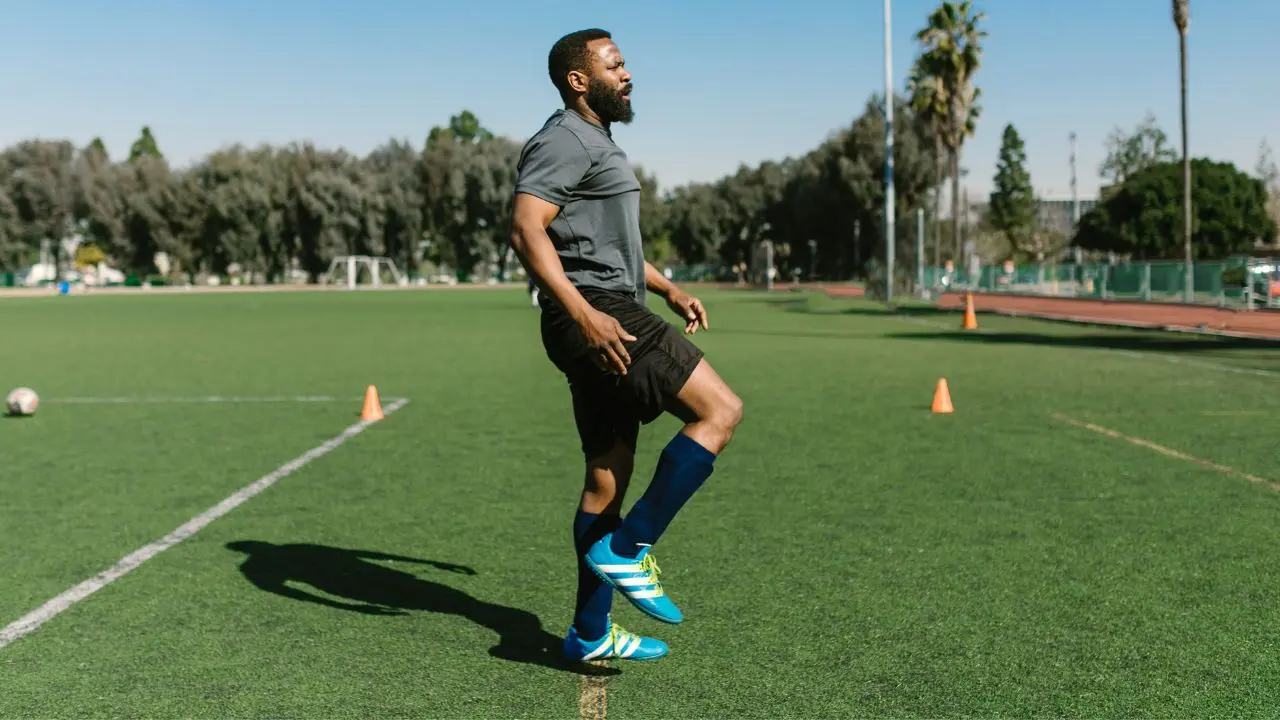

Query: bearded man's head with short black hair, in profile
left=547, top=28, right=635, bottom=124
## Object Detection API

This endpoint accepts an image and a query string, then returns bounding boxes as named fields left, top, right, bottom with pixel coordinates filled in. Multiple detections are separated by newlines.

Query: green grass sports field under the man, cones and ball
left=0, top=288, right=1280, bottom=719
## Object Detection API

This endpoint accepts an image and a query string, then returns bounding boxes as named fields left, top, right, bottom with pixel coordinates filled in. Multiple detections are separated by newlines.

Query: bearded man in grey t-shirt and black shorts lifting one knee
left=511, top=29, right=742, bottom=660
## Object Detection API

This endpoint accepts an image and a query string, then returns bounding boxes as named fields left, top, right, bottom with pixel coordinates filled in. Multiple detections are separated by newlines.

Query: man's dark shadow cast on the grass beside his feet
left=227, top=541, right=617, bottom=675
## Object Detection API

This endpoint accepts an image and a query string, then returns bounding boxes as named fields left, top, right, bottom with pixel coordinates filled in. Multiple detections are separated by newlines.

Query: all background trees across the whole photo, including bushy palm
left=0, top=0, right=1280, bottom=284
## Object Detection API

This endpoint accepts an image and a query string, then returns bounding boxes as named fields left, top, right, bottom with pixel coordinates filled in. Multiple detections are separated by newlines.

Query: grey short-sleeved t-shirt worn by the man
left=516, top=110, right=645, bottom=305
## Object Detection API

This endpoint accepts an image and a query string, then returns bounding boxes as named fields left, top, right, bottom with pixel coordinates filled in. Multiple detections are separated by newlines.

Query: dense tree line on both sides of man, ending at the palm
left=0, top=96, right=952, bottom=282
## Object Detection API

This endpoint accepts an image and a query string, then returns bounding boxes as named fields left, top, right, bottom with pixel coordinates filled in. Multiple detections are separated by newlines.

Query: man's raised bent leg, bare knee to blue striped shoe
left=586, top=359, right=742, bottom=623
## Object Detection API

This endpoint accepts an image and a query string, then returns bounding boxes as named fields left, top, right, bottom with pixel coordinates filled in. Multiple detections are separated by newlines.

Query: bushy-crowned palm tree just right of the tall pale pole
left=915, top=0, right=987, bottom=259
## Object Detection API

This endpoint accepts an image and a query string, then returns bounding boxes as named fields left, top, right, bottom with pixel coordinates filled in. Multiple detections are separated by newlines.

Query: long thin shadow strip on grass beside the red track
left=883, top=331, right=1280, bottom=363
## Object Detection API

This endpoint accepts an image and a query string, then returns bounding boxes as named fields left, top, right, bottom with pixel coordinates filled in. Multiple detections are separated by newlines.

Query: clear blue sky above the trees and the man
left=0, top=0, right=1280, bottom=197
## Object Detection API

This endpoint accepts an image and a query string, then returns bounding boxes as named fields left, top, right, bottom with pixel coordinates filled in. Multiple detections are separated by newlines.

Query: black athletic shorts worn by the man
left=541, top=288, right=703, bottom=460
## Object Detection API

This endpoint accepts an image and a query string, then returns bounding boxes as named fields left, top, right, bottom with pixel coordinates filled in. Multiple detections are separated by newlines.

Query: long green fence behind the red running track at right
left=924, top=258, right=1280, bottom=307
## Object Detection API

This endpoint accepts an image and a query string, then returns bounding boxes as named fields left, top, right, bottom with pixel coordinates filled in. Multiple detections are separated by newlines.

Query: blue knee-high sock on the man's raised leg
left=609, top=433, right=716, bottom=557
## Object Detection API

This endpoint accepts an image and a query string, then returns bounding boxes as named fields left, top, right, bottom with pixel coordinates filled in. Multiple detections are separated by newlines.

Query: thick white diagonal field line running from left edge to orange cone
left=0, top=398, right=408, bottom=648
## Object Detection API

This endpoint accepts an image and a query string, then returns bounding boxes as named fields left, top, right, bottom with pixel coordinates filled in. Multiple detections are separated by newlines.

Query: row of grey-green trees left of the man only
left=0, top=111, right=520, bottom=282
